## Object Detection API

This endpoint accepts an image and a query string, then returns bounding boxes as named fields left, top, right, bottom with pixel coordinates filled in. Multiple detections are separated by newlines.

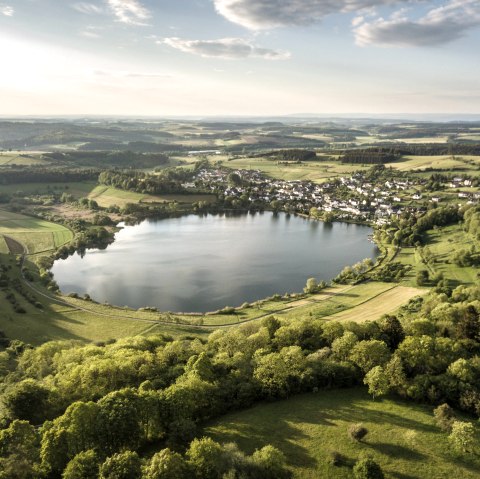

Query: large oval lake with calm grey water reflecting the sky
left=52, top=212, right=378, bottom=312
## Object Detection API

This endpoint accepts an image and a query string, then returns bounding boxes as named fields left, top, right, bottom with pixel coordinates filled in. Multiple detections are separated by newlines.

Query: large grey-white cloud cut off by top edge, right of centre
left=213, top=0, right=404, bottom=30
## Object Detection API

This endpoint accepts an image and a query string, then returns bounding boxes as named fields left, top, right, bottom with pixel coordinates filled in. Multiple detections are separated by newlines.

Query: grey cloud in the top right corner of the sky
left=354, top=0, right=480, bottom=47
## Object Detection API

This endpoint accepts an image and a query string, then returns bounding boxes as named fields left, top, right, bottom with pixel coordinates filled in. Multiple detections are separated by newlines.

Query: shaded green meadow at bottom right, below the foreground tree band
left=204, top=388, right=480, bottom=479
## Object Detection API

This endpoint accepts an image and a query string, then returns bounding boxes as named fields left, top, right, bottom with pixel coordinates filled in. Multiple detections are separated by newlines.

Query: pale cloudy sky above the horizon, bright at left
left=0, top=0, right=480, bottom=117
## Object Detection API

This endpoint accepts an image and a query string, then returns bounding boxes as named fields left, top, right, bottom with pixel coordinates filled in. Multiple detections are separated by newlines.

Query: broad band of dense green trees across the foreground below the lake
left=0, top=278, right=480, bottom=478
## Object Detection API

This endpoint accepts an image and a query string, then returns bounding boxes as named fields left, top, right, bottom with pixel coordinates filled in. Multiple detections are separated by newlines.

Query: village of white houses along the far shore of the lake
left=188, top=167, right=480, bottom=225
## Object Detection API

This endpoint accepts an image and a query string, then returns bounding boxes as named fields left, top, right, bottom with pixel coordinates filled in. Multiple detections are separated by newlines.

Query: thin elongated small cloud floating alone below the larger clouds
left=161, top=37, right=290, bottom=60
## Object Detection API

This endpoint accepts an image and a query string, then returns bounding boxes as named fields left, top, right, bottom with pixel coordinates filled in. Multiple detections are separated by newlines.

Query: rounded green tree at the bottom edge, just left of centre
left=187, top=437, right=226, bottom=479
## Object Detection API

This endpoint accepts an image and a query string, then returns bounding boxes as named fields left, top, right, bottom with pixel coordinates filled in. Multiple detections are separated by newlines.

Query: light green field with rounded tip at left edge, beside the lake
left=0, top=210, right=73, bottom=254
